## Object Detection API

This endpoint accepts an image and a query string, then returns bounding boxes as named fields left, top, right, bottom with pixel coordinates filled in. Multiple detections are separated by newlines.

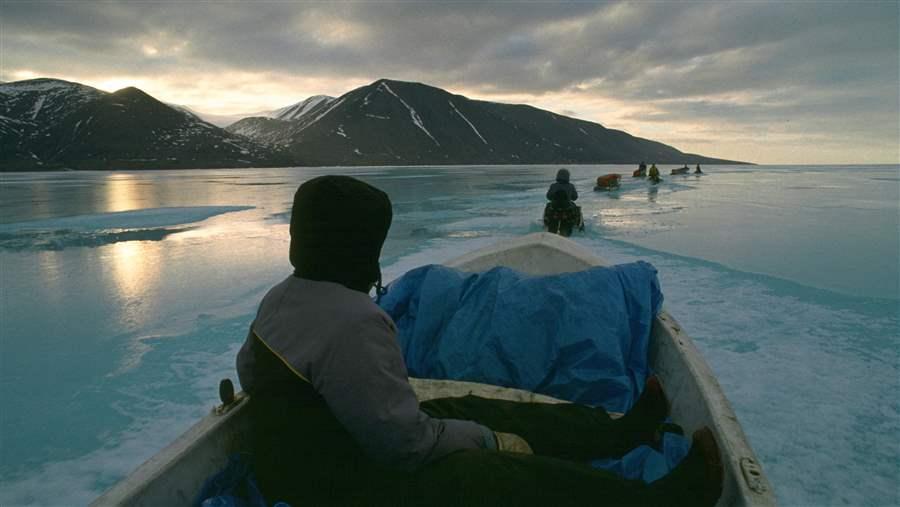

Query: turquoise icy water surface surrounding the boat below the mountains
left=0, top=166, right=900, bottom=506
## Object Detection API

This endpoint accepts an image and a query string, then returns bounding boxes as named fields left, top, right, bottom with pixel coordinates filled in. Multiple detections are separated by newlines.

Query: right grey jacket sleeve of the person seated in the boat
left=312, top=315, right=492, bottom=470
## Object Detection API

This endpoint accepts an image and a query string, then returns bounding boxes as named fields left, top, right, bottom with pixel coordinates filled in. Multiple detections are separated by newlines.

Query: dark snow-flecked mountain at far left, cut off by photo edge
left=0, top=79, right=285, bottom=170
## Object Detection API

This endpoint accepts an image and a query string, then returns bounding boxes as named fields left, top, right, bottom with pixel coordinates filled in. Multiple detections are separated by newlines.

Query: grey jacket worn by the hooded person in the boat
left=237, top=276, right=493, bottom=469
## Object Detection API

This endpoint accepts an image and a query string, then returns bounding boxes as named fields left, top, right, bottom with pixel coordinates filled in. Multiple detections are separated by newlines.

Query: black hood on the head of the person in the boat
left=290, top=175, right=393, bottom=292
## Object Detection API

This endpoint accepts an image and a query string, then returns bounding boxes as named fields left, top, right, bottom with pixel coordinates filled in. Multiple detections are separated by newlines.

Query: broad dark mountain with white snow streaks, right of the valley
left=227, top=79, right=744, bottom=165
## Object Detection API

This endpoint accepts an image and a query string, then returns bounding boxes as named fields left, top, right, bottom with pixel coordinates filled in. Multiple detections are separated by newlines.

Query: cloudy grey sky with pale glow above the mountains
left=0, top=0, right=900, bottom=164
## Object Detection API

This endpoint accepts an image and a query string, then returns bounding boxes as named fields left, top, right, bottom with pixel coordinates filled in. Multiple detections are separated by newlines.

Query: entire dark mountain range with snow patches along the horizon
left=0, top=78, right=745, bottom=170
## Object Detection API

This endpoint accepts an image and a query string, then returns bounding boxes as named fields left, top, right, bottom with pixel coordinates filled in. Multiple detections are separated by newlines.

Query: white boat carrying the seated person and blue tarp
left=91, top=233, right=775, bottom=507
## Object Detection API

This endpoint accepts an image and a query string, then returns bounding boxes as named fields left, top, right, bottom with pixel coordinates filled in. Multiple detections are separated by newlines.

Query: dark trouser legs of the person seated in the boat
left=408, top=396, right=666, bottom=506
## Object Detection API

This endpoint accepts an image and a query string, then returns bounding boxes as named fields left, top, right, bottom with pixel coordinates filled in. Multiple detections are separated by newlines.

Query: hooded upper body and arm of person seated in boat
left=237, top=176, right=494, bottom=505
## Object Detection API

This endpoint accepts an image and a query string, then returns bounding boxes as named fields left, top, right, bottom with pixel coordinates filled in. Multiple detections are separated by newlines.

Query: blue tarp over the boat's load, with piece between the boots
left=379, top=261, right=687, bottom=481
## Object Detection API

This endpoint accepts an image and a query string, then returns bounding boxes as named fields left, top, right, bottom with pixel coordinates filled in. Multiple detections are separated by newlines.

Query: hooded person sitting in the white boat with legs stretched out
left=237, top=176, right=723, bottom=506
